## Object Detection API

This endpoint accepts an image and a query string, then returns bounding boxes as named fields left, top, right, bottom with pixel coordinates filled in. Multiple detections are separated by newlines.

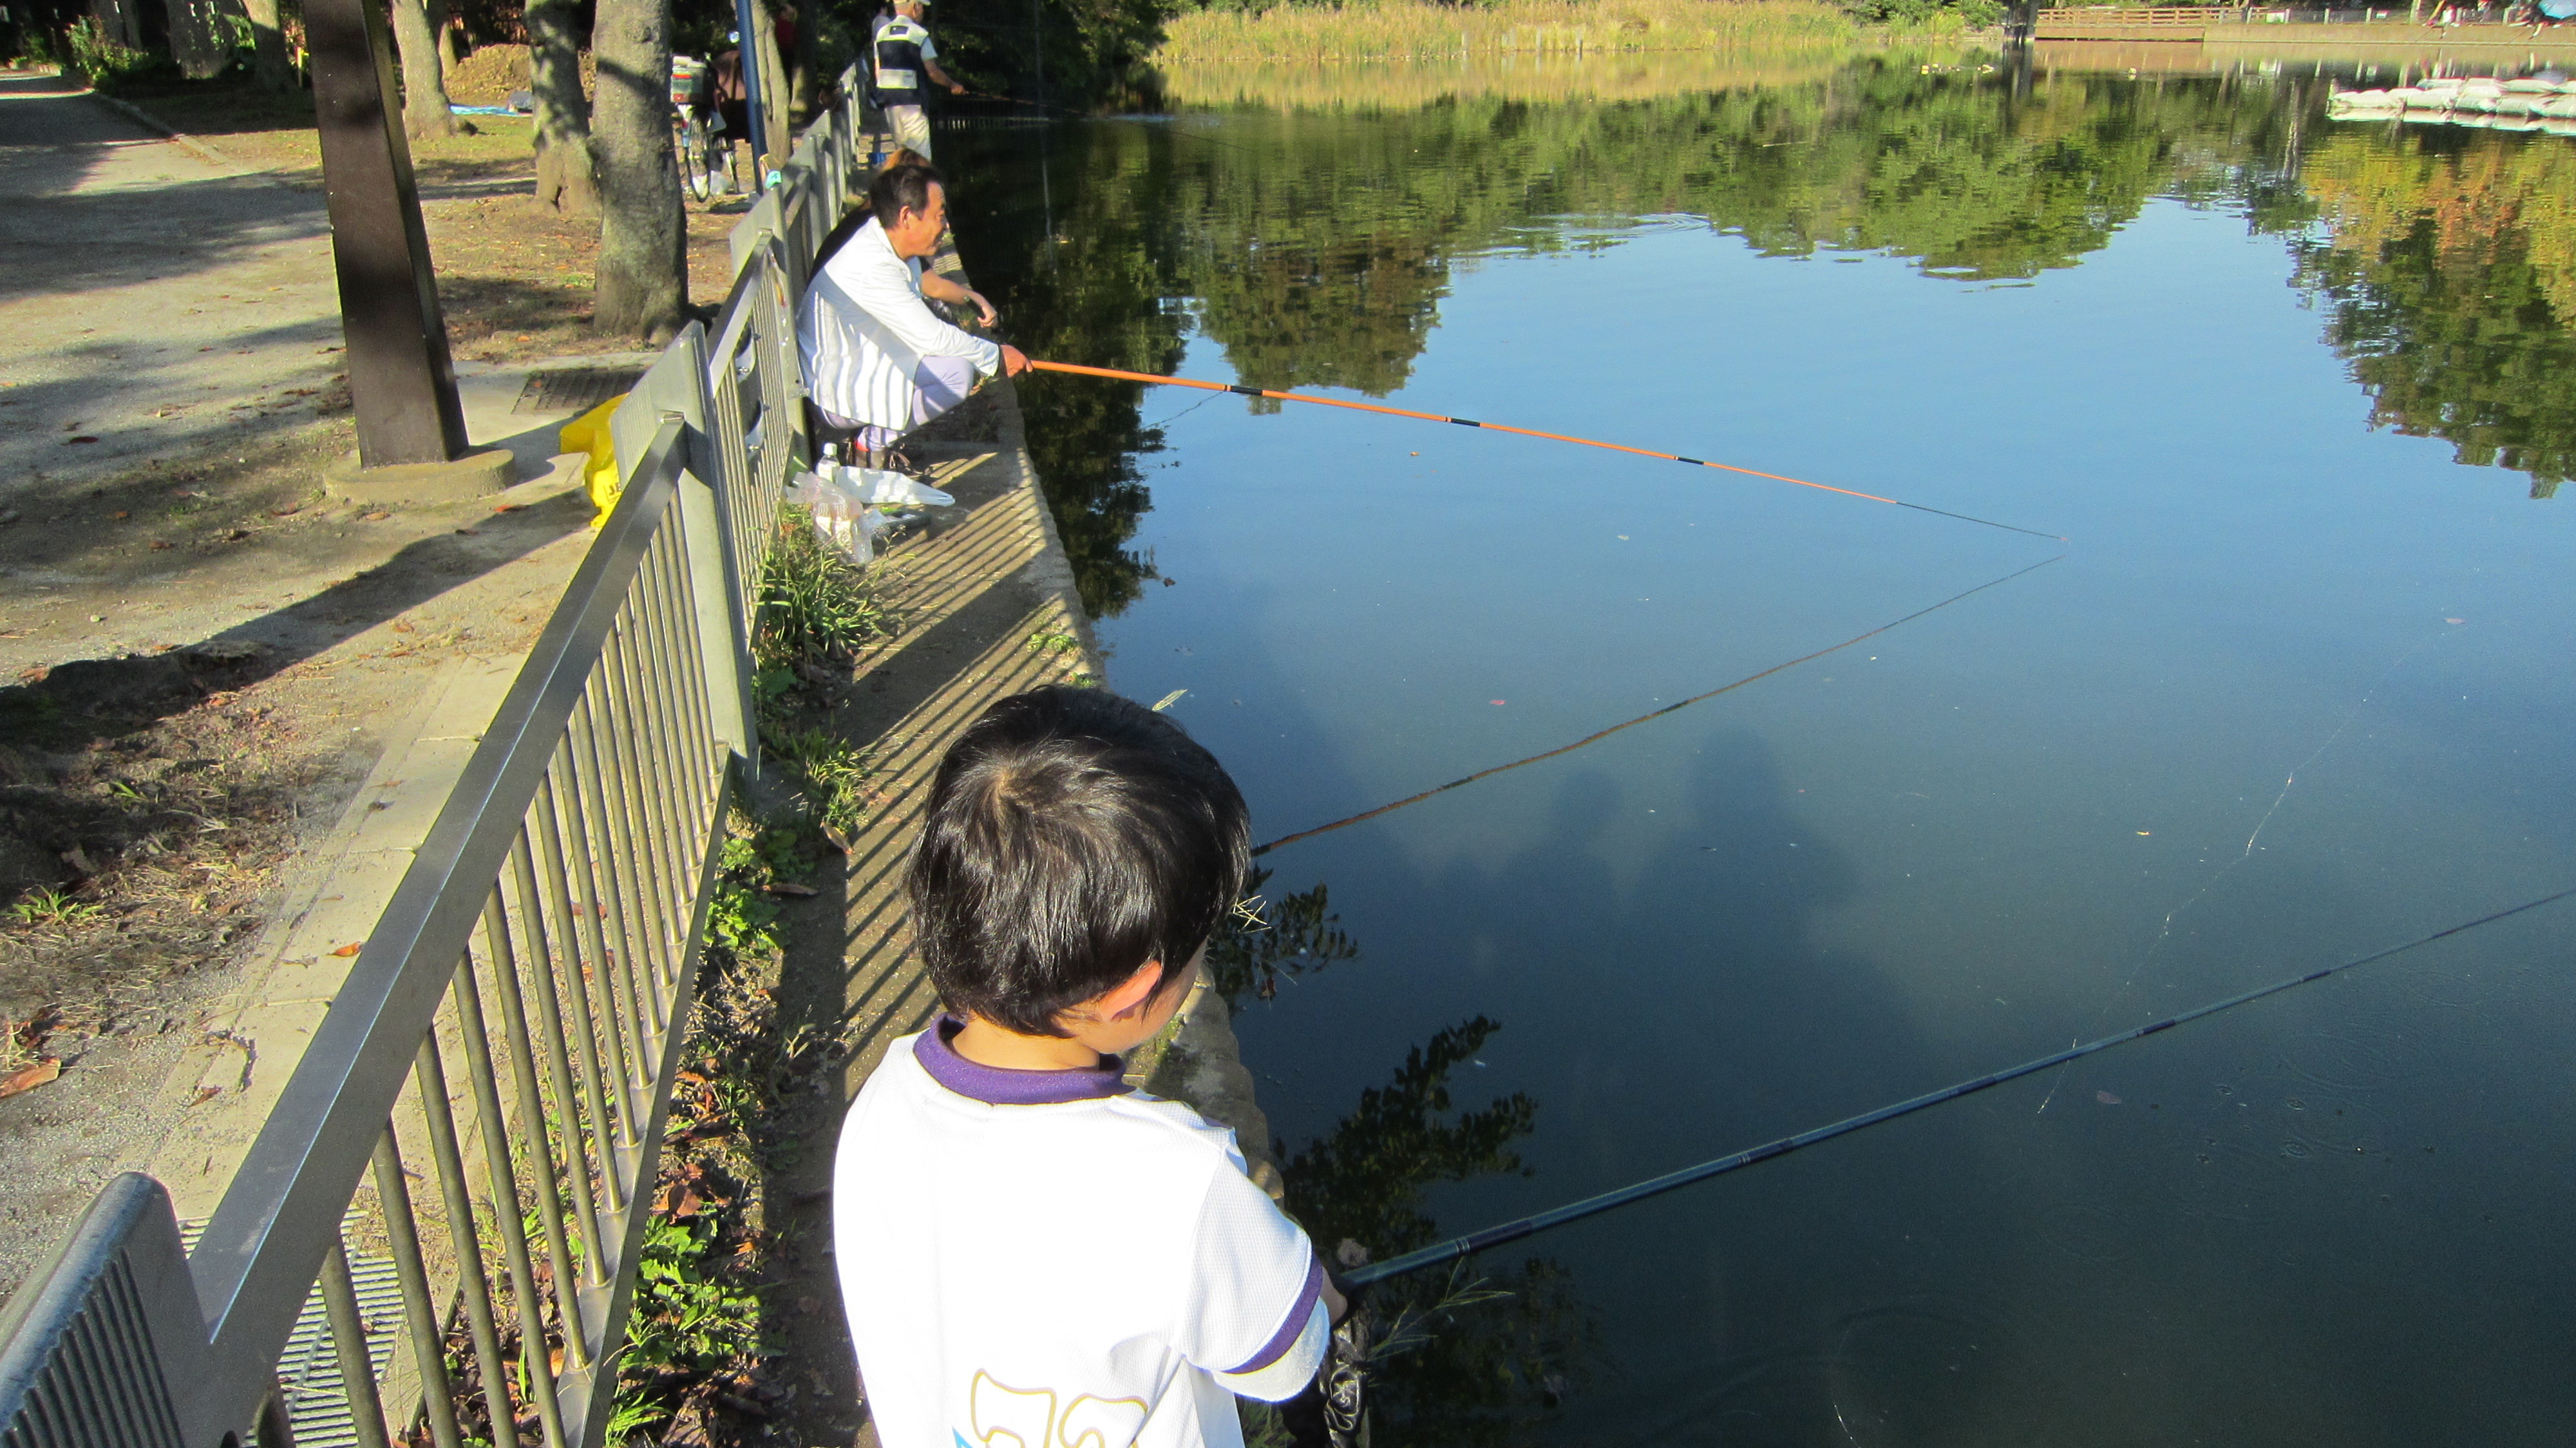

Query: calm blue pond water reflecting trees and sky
left=940, top=54, right=2576, bottom=1445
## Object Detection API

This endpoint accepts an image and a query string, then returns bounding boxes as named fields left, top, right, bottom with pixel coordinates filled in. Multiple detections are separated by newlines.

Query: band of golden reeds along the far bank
left=1149, top=0, right=1860, bottom=70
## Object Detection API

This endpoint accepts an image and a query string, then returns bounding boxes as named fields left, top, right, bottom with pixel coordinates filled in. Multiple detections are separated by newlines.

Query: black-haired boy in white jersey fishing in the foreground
left=832, top=685, right=1342, bottom=1448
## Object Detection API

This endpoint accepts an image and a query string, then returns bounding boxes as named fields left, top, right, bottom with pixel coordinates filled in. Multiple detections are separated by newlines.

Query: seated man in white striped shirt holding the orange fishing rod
left=796, top=157, right=1028, bottom=466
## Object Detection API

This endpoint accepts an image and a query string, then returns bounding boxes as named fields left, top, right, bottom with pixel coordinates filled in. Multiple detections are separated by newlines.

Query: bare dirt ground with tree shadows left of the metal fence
left=0, top=62, right=729, bottom=1293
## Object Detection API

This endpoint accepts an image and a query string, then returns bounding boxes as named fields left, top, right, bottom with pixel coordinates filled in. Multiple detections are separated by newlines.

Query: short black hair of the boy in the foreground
left=904, top=685, right=1252, bottom=1036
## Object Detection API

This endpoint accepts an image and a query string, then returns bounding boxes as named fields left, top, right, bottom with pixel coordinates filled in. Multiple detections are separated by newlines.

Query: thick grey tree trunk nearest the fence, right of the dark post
left=590, top=0, right=685, bottom=343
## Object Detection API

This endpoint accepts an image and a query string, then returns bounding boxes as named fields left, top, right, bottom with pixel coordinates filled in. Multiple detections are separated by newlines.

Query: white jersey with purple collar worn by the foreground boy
left=832, top=1018, right=1329, bottom=1448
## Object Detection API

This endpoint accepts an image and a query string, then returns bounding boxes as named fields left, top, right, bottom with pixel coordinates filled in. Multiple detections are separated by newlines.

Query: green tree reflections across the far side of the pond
left=940, top=54, right=2576, bottom=626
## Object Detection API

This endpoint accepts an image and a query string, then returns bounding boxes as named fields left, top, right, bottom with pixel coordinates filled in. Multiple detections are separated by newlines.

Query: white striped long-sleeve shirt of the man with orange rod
left=796, top=216, right=1002, bottom=430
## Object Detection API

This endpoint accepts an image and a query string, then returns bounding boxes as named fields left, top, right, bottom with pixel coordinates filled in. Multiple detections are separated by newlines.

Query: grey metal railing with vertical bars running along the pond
left=0, top=59, right=886, bottom=1448
